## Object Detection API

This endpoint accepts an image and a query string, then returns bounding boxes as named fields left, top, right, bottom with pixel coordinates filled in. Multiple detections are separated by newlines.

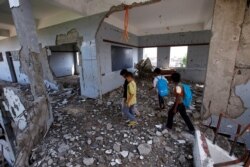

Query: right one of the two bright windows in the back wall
left=169, top=46, right=188, bottom=67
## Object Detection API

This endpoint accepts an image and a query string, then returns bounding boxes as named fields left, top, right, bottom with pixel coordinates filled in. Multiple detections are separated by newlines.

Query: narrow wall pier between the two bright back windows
left=157, top=47, right=170, bottom=68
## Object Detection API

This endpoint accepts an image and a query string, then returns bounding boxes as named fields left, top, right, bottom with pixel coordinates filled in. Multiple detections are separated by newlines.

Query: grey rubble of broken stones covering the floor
left=31, top=80, right=202, bottom=167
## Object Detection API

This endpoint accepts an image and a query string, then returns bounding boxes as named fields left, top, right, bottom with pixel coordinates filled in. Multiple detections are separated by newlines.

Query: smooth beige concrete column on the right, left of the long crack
left=203, top=0, right=246, bottom=117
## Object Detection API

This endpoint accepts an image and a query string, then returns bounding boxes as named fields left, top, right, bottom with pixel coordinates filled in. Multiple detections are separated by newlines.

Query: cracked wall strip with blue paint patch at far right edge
left=227, top=7, right=250, bottom=118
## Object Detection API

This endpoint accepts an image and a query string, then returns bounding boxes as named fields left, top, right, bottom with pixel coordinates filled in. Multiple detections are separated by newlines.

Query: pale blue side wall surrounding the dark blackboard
left=96, top=22, right=138, bottom=94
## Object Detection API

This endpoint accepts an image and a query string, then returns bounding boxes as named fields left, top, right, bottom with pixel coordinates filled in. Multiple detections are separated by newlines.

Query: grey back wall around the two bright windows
left=138, top=30, right=211, bottom=83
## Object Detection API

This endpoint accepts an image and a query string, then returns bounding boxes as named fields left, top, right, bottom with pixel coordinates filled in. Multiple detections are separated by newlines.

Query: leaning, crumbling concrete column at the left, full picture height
left=9, top=0, right=53, bottom=167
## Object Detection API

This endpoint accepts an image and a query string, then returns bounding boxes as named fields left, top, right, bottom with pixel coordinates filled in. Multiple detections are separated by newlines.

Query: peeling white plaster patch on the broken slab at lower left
left=4, top=88, right=27, bottom=130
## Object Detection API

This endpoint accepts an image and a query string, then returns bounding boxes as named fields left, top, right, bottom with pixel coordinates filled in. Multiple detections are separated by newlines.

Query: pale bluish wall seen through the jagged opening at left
left=49, top=52, right=75, bottom=77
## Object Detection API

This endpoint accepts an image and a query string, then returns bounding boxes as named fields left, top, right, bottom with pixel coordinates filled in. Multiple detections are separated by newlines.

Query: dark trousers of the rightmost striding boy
left=167, top=103, right=195, bottom=131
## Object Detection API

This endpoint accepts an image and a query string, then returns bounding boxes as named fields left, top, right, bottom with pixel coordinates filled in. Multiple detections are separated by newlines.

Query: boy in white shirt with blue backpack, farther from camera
left=151, top=68, right=168, bottom=110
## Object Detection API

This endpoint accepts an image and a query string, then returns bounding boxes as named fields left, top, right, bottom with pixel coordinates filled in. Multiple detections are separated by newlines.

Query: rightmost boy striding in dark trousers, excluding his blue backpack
left=167, top=73, right=195, bottom=134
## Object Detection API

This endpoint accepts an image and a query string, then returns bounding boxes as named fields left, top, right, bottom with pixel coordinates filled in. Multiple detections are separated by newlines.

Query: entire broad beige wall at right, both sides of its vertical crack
left=203, top=0, right=250, bottom=118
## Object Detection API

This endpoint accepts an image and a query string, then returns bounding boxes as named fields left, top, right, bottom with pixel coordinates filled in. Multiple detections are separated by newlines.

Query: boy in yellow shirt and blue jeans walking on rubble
left=123, top=72, right=137, bottom=126
